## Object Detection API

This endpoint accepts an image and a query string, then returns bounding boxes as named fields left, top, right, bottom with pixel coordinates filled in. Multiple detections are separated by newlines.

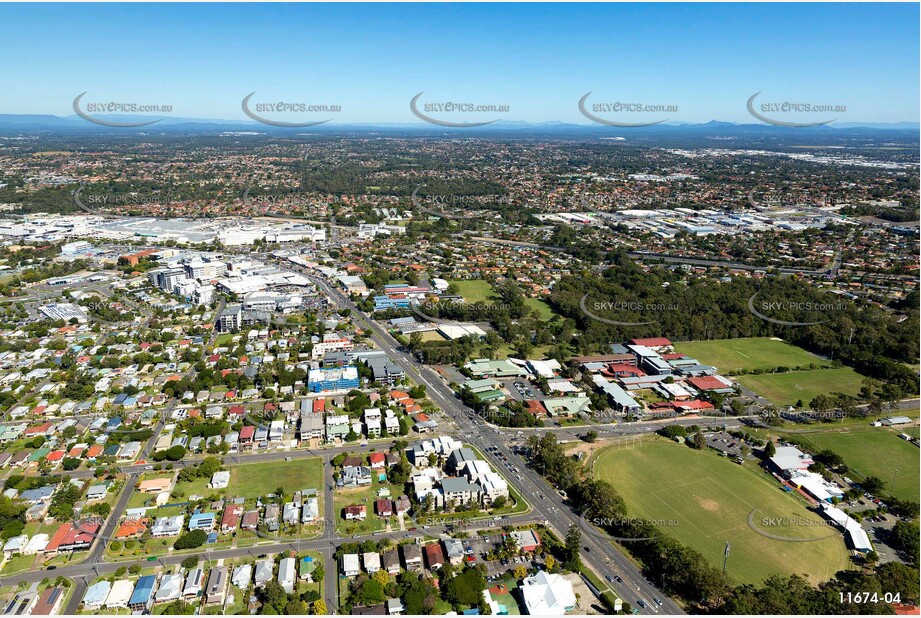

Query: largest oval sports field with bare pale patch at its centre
left=592, top=438, right=850, bottom=584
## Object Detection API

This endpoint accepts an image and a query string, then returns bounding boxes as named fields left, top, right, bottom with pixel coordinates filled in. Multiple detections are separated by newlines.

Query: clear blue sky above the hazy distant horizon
left=0, top=3, right=919, bottom=123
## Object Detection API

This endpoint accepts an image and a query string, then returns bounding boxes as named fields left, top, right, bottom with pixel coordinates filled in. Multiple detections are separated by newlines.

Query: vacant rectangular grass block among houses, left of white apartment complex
left=228, top=457, right=324, bottom=498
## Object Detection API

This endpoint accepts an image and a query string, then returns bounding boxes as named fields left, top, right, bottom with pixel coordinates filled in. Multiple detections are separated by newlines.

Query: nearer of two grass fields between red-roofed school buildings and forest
left=738, top=367, right=864, bottom=406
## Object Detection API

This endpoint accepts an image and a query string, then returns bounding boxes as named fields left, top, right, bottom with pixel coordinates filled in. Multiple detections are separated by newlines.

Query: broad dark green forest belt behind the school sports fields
left=549, top=254, right=919, bottom=396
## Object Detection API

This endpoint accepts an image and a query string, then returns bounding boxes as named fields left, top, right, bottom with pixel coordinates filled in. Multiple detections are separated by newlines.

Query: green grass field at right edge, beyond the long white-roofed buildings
left=795, top=423, right=921, bottom=502
